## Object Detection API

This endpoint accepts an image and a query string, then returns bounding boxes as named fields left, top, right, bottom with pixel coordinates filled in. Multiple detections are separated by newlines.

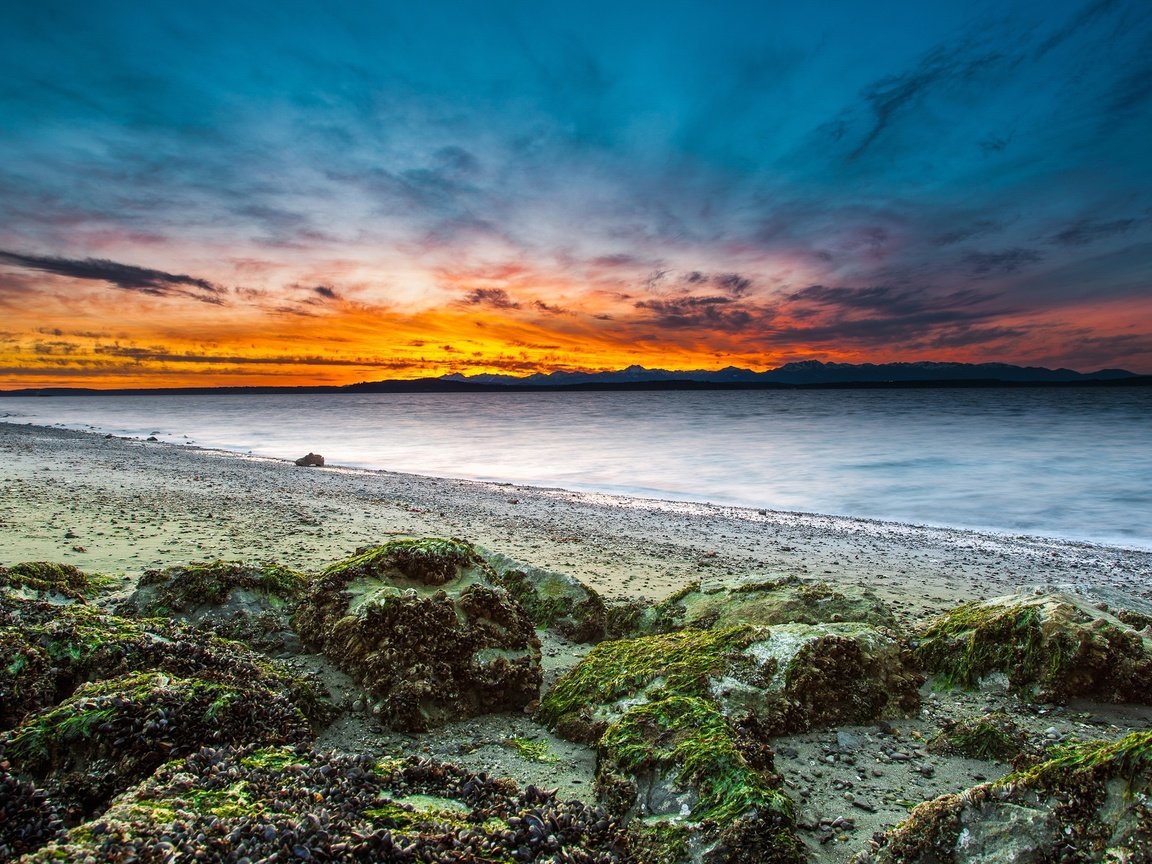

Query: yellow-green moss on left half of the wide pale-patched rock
left=538, top=627, right=759, bottom=727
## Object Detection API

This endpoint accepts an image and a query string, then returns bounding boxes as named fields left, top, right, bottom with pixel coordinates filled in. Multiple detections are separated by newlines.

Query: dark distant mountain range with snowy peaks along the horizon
left=0, top=361, right=1152, bottom=396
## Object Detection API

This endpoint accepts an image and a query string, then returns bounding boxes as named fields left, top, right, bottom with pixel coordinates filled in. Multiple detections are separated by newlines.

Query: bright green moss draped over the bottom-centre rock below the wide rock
left=597, top=696, right=791, bottom=826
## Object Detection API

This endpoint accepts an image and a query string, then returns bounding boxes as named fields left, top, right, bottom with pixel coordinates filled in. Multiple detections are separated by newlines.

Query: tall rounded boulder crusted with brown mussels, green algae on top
left=294, top=539, right=541, bottom=729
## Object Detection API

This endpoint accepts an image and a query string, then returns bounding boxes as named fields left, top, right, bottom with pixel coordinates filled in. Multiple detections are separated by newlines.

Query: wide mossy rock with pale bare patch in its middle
left=539, top=623, right=923, bottom=743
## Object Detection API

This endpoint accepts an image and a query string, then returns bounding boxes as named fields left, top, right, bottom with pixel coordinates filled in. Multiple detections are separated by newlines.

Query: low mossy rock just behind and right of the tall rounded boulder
left=480, top=551, right=606, bottom=642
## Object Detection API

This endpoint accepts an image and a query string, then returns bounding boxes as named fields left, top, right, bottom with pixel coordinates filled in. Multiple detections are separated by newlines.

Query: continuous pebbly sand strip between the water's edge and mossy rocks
left=0, top=422, right=1152, bottom=614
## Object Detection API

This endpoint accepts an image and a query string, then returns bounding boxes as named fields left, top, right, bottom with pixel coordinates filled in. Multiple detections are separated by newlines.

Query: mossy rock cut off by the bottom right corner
left=856, top=732, right=1152, bottom=864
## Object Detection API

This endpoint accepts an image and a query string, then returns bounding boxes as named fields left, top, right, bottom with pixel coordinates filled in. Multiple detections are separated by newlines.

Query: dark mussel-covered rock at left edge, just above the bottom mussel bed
left=0, top=672, right=311, bottom=817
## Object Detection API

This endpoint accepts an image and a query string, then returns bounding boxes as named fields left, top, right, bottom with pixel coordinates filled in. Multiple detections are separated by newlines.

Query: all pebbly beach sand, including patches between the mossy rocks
left=0, top=423, right=1152, bottom=864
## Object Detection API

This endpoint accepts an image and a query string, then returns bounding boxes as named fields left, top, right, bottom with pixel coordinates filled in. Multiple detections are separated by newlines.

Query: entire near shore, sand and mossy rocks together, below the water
left=0, top=424, right=1152, bottom=864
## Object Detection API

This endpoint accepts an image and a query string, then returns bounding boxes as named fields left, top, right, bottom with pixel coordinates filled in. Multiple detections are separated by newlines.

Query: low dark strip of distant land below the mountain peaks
left=0, top=376, right=1152, bottom=397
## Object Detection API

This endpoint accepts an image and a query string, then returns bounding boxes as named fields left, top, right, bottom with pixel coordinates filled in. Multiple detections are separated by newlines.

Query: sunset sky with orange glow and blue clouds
left=0, top=0, right=1152, bottom=388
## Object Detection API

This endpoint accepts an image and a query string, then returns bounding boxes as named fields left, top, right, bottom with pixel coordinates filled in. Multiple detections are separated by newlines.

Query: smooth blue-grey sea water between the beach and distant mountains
left=0, top=387, right=1152, bottom=548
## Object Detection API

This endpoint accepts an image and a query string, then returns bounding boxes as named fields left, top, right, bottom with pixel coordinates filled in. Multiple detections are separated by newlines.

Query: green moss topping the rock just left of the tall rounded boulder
left=139, top=561, right=305, bottom=612
